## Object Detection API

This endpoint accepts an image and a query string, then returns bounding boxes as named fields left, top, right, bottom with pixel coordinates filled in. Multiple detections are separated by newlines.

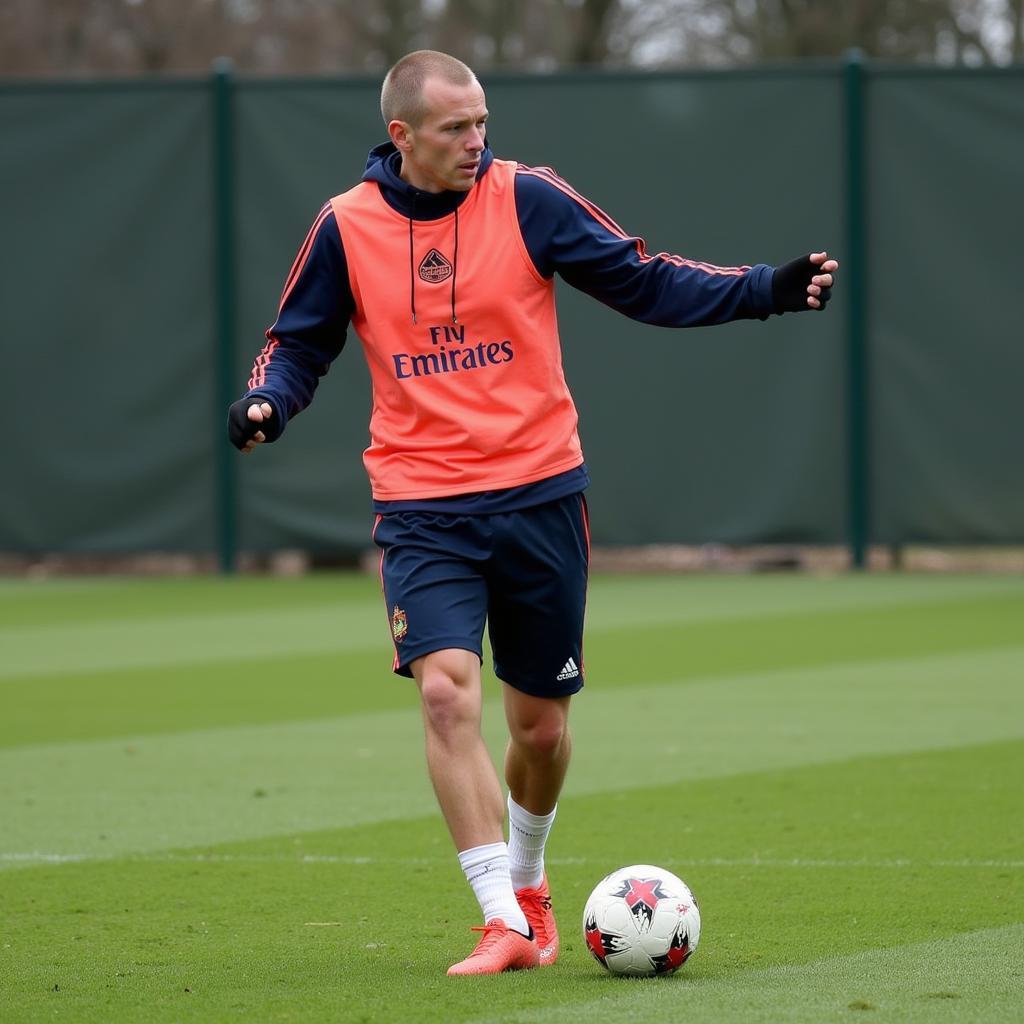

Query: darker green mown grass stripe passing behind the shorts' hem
left=0, top=585, right=1024, bottom=746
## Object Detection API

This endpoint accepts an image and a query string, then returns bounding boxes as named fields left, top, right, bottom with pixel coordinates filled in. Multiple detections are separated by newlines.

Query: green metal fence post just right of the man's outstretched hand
left=842, top=50, right=870, bottom=569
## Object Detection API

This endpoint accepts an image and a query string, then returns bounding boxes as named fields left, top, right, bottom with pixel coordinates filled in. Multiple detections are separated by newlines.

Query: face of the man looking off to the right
left=392, top=78, right=487, bottom=193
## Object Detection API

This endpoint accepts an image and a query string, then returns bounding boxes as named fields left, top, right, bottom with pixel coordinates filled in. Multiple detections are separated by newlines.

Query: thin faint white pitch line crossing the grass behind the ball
left=0, top=852, right=1024, bottom=870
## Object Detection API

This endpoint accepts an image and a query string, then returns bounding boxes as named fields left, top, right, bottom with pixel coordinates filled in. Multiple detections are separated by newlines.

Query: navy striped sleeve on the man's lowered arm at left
left=247, top=203, right=355, bottom=437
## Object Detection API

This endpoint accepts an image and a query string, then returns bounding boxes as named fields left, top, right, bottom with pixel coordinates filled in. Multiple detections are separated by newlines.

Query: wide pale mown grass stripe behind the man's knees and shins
left=0, top=649, right=1024, bottom=856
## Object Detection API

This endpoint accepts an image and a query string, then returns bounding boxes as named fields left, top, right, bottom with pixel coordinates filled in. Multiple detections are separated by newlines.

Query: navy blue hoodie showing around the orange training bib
left=248, top=142, right=774, bottom=512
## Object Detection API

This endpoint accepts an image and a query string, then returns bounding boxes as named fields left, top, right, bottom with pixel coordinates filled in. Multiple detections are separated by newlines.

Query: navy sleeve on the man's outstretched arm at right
left=515, top=165, right=774, bottom=327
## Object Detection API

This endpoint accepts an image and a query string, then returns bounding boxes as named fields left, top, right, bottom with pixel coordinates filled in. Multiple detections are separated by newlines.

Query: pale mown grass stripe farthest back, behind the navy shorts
left=0, top=578, right=1024, bottom=680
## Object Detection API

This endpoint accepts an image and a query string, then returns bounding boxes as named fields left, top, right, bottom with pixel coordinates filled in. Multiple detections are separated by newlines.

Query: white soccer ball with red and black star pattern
left=583, top=864, right=700, bottom=977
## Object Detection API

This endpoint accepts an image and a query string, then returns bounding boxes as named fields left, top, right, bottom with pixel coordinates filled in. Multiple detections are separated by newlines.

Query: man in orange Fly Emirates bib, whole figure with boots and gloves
left=228, top=50, right=839, bottom=975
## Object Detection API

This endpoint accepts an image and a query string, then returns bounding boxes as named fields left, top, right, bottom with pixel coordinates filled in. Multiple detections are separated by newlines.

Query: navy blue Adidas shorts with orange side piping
left=374, top=493, right=590, bottom=697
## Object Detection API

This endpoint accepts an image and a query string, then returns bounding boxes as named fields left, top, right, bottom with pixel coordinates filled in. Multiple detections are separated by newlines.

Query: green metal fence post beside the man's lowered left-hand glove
left=210, top=57, right=238, bottom=572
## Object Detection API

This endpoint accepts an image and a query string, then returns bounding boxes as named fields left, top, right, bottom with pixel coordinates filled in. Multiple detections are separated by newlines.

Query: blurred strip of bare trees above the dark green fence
left=0, top=0, right=1024, bottom=75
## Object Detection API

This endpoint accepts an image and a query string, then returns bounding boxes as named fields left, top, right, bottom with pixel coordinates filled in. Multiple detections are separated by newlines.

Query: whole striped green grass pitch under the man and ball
left=0, top=575, right=1024, bottom=1024
